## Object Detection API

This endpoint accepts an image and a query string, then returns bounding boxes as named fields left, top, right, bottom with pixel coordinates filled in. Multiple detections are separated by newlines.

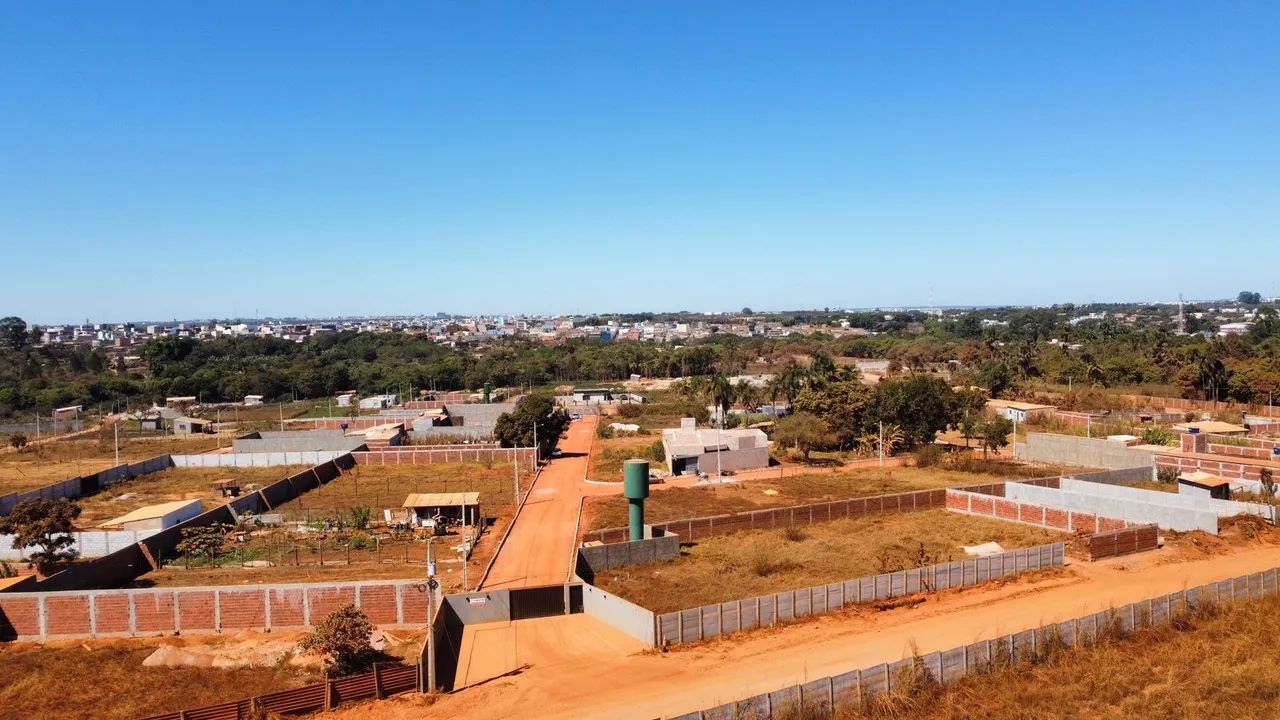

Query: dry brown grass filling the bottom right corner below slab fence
left=824, top=597, right=1280, bottom=720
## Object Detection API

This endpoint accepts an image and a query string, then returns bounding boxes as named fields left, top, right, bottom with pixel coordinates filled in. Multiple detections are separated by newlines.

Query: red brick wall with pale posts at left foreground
left=0, top=580, right=426, bottom=641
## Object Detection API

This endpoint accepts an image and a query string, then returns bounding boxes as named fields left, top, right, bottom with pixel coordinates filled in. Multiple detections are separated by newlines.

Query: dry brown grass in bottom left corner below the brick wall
left=0, top=639, right=319, bottom=720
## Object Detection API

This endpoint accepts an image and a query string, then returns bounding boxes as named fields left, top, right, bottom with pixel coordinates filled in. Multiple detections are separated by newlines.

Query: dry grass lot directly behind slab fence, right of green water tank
left=595, top=510, right=1068, bottom=612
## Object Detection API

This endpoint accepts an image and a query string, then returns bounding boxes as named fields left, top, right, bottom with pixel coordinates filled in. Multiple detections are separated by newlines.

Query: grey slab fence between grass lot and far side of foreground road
left=657, top=543, right=1066, bottom=646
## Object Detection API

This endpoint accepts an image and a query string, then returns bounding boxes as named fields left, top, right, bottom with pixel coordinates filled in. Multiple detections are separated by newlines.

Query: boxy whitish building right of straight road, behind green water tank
left=662, top=418, right=769, bottom=475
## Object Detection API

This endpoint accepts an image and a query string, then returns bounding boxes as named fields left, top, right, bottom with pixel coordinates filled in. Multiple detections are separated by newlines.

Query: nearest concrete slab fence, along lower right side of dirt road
left=672, top=569, right=1280, bottom=720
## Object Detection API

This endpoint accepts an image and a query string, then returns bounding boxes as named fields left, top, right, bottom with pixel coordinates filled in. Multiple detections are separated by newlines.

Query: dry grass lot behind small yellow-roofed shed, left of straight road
left=275, top=462, right=530, bottom=521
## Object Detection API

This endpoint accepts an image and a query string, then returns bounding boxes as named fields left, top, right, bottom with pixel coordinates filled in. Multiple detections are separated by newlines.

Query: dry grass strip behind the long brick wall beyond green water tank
left=582, top=465, right=1048, bottom=529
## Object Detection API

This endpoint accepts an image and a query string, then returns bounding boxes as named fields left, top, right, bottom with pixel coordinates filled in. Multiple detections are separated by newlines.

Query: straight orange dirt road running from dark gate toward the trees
left=481, top=416, right=599, bottom=589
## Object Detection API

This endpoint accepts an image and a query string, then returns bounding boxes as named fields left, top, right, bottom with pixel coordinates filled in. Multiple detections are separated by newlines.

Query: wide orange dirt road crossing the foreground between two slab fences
left=333, top=546, right=1280, bottom=720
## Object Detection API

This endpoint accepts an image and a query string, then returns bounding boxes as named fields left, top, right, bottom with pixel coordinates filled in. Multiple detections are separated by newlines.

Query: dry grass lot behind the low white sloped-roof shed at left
left=78, top=465, right=306, bottom=528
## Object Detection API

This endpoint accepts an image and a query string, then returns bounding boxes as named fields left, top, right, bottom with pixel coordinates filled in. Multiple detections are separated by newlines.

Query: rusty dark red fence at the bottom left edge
left=145, top=664, right=420, bottom=720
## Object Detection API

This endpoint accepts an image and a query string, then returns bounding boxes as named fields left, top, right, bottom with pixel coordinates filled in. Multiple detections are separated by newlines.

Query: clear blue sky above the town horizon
left=0, top=0, right=1280, bottom=323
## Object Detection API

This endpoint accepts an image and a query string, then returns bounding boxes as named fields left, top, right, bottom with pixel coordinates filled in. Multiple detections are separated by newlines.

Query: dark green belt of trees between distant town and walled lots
left=0, top=297, right=1280, bottom=416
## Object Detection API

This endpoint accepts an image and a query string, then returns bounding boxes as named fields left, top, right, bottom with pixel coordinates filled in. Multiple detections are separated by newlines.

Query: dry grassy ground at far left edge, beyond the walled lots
left=0, top=437, right=221, bottom=493
